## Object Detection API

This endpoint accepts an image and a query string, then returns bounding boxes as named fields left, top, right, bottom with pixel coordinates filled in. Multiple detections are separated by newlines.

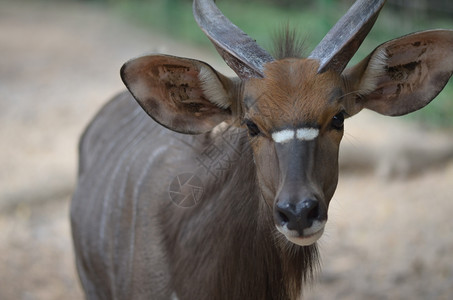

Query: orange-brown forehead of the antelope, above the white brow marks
left=244, top=59, right=343, bottom=129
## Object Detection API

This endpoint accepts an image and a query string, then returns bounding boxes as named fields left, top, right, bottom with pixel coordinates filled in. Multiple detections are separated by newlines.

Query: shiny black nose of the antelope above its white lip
left=275, top=198, right=325, bottom=236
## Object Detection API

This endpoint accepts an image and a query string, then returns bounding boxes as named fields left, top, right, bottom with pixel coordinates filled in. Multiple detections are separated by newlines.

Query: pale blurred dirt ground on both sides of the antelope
left=0, top=0, right=453, bottom=300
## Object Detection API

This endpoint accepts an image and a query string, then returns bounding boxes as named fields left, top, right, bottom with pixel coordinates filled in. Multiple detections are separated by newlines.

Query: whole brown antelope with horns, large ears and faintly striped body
left=71, top=0, right=453, bottom=300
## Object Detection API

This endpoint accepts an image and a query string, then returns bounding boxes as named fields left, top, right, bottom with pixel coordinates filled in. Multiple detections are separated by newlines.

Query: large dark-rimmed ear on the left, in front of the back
left=121, top=55, right=235, bottom=134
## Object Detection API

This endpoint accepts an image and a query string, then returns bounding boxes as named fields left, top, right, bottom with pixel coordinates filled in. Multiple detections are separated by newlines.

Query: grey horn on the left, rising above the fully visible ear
left=193, top=0, right=274, bottom=79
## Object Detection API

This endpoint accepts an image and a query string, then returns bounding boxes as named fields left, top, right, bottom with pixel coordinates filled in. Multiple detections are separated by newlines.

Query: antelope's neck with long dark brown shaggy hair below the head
left=164, top=127, right=318, bottom=299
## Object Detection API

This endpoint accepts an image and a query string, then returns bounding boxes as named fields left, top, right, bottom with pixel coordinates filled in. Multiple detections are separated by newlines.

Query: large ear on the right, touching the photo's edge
left=343, top=30, right=453, bottom=116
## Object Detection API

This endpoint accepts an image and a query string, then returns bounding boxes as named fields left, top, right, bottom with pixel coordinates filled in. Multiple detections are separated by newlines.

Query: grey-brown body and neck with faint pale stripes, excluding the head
left=71, top=92, right=317, bottom=300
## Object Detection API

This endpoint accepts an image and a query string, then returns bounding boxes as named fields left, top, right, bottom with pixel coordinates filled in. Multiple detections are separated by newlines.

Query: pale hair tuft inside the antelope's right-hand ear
left=358, top=49, right=388, bottom=95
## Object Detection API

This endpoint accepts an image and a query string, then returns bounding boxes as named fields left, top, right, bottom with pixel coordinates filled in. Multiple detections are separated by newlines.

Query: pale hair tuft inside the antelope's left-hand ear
left=198, top=66, right=231, bottom=109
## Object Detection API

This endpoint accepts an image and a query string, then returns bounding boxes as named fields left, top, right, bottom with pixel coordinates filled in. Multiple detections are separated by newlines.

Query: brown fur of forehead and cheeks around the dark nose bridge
left=244, top=59, right=343, bottom=217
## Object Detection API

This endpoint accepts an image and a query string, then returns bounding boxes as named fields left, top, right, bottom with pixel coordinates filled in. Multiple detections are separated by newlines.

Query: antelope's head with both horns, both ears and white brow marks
left=121, top=0, right=453, bottom=246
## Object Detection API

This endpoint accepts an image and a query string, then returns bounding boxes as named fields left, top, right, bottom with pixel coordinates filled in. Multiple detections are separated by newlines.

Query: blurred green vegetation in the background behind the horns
left=97, top=0, right=453, bottom=127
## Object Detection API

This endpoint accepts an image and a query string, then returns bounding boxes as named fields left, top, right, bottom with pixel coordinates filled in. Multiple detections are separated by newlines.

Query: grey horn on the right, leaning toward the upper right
left=309, top=0, right=385, bottom=73
